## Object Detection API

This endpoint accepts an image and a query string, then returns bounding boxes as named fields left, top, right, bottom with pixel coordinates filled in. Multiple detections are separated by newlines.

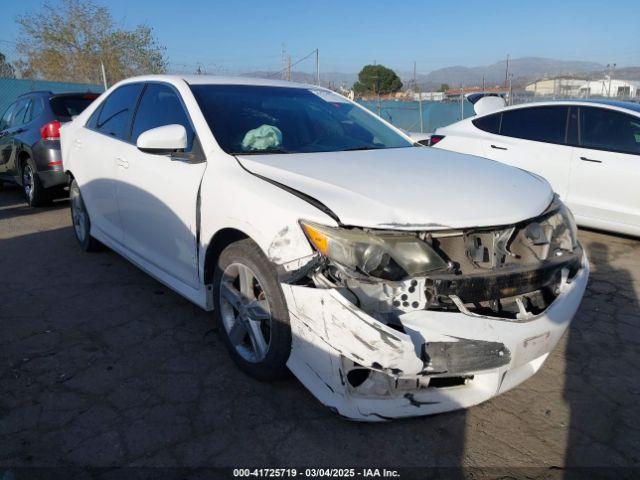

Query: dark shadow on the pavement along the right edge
left=564, top=233, right=640, bottom=479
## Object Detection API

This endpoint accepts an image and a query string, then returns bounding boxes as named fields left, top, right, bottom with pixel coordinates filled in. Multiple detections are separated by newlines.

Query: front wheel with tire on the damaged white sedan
left=213, top=239, right=291, bottom=380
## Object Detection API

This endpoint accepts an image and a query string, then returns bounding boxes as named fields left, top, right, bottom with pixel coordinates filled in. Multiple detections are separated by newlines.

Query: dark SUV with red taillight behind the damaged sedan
left=0, top=92, right=98, bottom=206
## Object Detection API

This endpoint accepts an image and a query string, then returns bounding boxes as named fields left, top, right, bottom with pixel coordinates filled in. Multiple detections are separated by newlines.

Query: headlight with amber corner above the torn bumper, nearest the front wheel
left=300, top=221, right=447, bottom=280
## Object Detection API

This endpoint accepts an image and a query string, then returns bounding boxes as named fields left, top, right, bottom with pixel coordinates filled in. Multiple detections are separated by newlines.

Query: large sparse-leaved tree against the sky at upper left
left=16, top=0, right=167, bottom=83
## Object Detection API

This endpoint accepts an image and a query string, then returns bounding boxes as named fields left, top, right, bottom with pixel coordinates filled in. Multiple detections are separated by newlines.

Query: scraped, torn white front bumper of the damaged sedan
left=281, top=254, right=589, bottom=421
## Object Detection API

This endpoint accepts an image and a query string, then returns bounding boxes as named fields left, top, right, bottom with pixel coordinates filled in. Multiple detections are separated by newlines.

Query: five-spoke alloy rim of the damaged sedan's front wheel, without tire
left=220, top=263, right=271, bottom=363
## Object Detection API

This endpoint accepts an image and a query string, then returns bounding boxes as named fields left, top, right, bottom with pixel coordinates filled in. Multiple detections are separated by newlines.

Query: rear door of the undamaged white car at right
left=476, top=105, right=572, bottom=197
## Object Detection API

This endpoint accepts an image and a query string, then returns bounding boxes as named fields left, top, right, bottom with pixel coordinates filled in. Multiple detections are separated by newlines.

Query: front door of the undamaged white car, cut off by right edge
left=569, top=106, right=640, bottom=228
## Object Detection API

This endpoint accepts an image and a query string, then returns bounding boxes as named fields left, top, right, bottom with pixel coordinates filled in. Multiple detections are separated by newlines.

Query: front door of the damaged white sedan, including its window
left=117, top=83, right=206, bottom=288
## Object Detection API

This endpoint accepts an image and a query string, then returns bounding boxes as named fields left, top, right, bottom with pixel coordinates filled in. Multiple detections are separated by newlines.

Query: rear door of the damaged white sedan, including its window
left=71, top=83, right=144, bottom=242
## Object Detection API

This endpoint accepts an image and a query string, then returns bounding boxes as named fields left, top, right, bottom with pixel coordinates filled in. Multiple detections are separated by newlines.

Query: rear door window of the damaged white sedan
left=89, top=83, right=143, bottom=141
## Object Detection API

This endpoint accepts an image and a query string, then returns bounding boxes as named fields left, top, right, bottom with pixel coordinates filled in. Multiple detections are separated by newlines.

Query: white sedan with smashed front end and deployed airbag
left=61, top=75, right=588, bottom=421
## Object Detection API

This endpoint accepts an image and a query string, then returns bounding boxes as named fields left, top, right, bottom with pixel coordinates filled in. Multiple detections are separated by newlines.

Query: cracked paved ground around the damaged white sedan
left=0, top=182, right=640, bottom=478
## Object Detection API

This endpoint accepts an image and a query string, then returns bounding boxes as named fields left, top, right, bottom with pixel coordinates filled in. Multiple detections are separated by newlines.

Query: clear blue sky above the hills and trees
left=0, top=0, right=640, bottom=73
